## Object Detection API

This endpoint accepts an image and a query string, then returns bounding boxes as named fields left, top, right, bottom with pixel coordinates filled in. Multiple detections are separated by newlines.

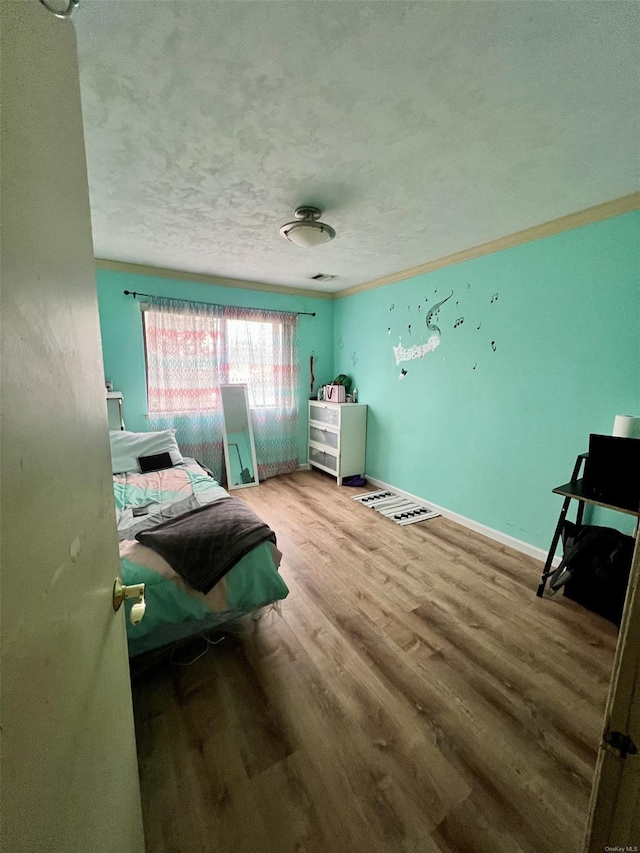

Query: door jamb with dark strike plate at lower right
left=584, top=544, right=640, bottom=853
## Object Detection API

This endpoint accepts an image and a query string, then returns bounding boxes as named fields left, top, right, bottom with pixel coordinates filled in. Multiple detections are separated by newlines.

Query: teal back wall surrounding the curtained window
left=97, top=270, right=334, bottom=462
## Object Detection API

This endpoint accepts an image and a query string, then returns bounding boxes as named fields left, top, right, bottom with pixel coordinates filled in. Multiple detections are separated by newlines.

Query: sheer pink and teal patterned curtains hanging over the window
left=144, top=297, right=298, bottom=480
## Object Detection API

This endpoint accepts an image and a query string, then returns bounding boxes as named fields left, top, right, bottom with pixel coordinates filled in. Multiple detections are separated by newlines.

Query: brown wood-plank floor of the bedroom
left=134, top=472, right=617, bottom=853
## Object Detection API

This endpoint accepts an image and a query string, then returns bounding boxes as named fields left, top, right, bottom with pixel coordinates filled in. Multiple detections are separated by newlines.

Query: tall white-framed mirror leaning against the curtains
left=220, top=385, right=258, bottom=489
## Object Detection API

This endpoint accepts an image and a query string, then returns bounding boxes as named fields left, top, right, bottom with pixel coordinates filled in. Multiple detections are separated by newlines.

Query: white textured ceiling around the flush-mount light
left=75, top=0, right=640, bottom=290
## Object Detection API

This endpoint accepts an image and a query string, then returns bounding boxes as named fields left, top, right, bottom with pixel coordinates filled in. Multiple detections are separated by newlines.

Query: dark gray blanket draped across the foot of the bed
left=136, top=497, right=276, bottom=593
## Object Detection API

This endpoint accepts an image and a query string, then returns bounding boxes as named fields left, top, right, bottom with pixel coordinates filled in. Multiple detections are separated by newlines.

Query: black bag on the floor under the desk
left=549, top=521, right=635, bottom=625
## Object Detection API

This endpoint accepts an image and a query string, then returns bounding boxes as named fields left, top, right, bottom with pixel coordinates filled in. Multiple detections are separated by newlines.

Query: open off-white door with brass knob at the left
left=0, top=0, right=144, bottom=853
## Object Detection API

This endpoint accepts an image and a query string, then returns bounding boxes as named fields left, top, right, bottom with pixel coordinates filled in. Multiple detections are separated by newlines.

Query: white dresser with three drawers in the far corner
left=309, top=400, right=367, bottom=486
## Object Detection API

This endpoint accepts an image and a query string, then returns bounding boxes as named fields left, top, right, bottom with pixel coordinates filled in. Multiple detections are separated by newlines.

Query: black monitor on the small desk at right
left=584, top=434, right=640, bottom=512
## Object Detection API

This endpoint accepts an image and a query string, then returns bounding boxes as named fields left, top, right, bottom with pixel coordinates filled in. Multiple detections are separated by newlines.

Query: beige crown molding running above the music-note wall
left=335, top=192, right=640, bottom=299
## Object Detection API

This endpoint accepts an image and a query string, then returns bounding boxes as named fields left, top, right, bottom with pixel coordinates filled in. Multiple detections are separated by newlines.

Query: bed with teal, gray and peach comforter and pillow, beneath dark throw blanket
left=110, top=431, right=289, bottom=657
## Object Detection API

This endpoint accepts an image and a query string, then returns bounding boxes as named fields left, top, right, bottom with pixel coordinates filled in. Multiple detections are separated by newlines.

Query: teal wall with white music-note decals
left=334, top=212, right=640, bottom=549
